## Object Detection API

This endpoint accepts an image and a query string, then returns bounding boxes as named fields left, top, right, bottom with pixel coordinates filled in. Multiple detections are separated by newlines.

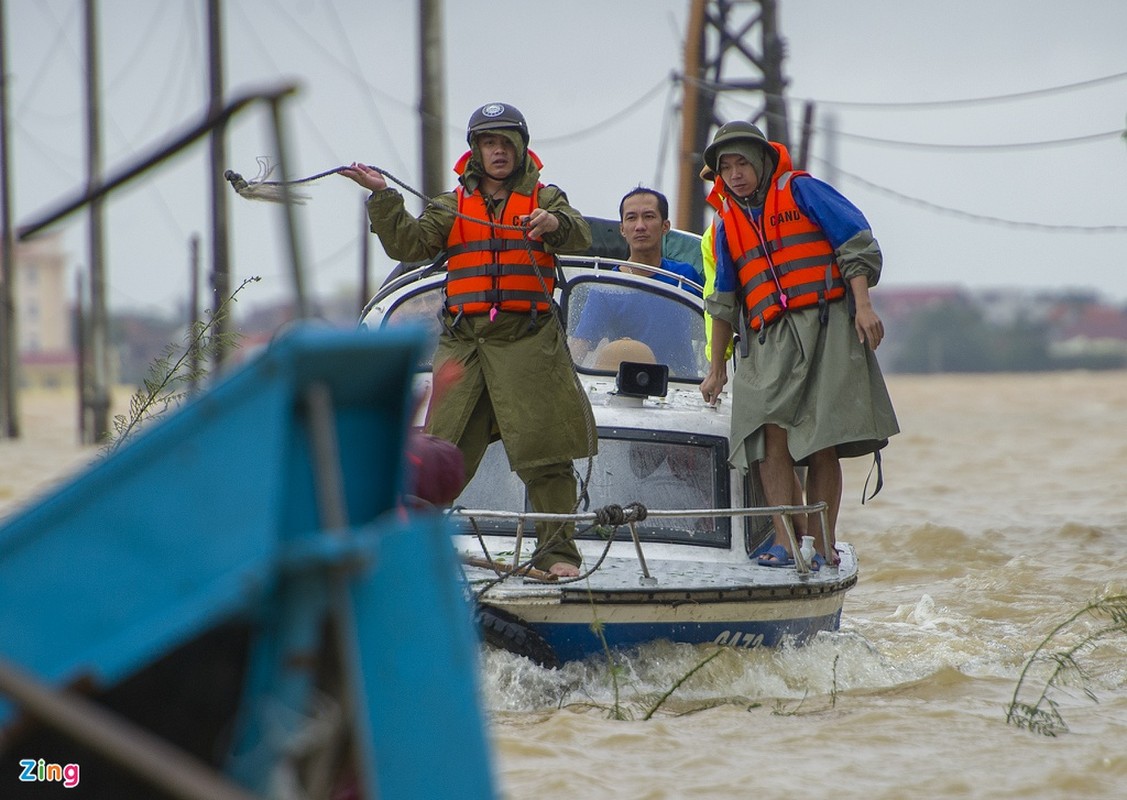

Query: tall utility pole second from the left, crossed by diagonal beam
left=83, top=0, right=110, bottom=442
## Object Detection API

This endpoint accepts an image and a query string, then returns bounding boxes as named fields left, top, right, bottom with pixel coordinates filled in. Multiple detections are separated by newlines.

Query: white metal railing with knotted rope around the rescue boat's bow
left=450, top=501, right=833, bottom=583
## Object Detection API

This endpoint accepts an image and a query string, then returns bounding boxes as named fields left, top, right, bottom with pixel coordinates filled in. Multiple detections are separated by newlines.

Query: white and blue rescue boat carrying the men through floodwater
left=361, top=219, right=858, bottom=666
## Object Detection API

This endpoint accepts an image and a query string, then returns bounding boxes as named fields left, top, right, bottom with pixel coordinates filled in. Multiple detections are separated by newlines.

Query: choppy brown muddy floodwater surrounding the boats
left=0, top=372, right=1127, bottom=800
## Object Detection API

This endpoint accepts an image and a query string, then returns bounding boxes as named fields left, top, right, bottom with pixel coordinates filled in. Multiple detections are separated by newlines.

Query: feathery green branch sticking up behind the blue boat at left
left=106, top=276, right=261, bottom=453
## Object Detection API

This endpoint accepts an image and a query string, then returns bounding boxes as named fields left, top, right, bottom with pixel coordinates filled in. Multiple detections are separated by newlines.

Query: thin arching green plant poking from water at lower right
left=1005, top=595, right=1127, bottom=736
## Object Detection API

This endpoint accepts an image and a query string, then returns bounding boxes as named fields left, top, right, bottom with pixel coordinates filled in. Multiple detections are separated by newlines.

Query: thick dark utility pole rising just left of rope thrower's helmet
left=419, top=0, right=446, bottom=197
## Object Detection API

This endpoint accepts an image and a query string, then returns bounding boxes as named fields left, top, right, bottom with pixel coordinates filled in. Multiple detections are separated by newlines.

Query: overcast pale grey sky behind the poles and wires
left=6, top=0, right=1127, bottom=313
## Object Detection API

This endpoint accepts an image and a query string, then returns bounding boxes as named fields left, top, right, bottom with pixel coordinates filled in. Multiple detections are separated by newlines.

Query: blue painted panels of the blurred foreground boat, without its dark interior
left=0, top=328, right=494, bottom=798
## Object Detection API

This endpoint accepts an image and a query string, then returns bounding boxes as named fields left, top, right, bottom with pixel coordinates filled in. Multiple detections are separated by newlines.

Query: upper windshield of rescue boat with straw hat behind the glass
left=565, top=275, right=708, bottom=382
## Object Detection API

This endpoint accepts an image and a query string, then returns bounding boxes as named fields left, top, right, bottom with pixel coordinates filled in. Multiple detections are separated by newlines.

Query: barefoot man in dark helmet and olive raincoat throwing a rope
left=341, top=103, right=597, bottom=577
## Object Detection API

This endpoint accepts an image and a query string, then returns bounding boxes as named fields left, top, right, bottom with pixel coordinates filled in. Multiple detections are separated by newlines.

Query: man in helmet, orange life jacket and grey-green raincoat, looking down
left=701, top=121, right=899, bottom=566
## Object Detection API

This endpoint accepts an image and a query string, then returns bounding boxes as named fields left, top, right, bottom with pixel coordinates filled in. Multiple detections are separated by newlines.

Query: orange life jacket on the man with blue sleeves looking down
left=719, top=171, right=845, bottom=331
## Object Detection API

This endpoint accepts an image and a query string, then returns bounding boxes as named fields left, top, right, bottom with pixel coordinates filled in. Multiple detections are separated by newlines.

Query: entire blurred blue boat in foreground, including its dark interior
left=0, top=328, right=495, bottom=800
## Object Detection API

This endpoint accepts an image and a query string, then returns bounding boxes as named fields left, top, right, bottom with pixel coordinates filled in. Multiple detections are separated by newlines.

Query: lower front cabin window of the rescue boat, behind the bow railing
left=454, top=429, right=731, bottom=548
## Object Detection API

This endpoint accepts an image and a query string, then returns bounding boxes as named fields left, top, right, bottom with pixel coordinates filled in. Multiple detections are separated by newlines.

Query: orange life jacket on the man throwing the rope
left=446, top=157, right=556, bottom=315
